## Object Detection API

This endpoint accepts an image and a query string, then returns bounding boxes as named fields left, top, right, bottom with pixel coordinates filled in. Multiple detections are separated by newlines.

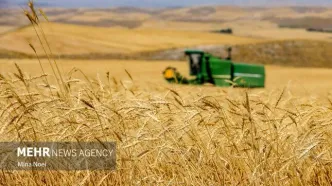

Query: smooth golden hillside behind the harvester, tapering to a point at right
left=0, top=23, right=261, bottom=55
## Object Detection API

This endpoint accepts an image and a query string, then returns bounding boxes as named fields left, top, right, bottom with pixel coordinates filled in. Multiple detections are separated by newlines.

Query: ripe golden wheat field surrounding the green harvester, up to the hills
left=0, top=2, right=332, bottom=186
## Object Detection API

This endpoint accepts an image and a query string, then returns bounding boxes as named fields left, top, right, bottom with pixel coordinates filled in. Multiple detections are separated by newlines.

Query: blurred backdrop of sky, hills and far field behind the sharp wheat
left=0, top=0, right=332, bottom=95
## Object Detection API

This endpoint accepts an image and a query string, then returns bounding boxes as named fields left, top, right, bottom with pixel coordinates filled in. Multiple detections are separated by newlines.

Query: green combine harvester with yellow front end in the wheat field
left=163, top=48, right=265, bottom=88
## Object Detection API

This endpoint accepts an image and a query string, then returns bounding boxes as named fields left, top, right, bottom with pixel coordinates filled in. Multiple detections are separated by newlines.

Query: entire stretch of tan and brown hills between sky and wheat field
left=0, top=6, right=332, bottom=67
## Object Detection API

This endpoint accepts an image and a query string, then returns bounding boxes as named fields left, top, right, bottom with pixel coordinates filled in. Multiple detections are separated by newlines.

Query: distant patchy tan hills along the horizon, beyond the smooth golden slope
left=0, top=6, right=332, bottom=41
